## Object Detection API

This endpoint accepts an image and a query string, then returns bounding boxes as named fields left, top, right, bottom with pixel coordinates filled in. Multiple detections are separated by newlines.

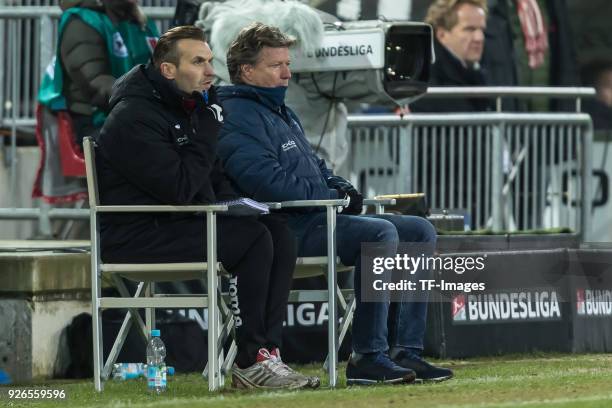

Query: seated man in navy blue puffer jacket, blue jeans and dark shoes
left=219, top=23, right=452, bottom=384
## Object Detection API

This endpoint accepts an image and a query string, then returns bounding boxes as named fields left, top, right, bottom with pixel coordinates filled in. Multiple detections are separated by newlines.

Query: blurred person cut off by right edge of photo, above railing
left=581, top=60, right=612, bottom=130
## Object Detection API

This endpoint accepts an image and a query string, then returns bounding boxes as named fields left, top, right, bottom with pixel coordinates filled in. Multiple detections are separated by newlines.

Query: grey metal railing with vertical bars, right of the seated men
left=348, top=113, right=592, bottom=237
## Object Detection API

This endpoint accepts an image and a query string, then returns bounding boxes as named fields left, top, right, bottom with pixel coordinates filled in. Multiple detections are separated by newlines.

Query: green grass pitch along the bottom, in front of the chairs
left=0, top=354, right=612, bottom=408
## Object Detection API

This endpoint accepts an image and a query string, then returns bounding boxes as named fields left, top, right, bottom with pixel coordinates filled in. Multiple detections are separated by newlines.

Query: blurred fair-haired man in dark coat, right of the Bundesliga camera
left=411, top=0, right=493, bottom=112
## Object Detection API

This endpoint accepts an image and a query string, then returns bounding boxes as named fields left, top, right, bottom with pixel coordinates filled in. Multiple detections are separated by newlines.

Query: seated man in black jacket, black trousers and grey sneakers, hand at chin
left=96, top=26, right=318, bottom=388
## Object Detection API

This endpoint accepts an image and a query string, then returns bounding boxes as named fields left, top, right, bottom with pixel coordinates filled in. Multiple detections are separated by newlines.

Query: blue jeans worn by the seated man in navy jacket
left=298, top=213, right=436, bottom=353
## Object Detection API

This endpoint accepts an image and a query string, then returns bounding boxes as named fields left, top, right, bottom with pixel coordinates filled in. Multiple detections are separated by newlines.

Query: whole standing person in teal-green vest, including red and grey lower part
left=32, top=0, right=159, bottom=203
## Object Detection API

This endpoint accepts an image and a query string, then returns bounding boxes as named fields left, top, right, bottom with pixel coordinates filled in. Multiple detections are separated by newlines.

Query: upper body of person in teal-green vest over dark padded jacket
left=38, top=0, right=159, bottom=141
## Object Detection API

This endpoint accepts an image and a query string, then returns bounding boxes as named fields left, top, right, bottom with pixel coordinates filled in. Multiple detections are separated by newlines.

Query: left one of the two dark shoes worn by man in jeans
left=346, top=352, right=416, bottom=385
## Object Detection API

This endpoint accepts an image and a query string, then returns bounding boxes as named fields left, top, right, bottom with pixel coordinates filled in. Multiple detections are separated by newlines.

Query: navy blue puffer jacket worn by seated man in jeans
left=218, top=85, right=338, bottom=235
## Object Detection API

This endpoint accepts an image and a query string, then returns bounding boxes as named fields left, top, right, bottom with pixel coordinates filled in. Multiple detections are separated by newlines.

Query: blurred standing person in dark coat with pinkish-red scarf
left=482, top=0, right=578, bottom=110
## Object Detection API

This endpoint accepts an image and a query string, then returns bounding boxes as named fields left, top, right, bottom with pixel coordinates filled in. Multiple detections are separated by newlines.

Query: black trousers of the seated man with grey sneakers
left=101, top=214, right=297, bottom=368
